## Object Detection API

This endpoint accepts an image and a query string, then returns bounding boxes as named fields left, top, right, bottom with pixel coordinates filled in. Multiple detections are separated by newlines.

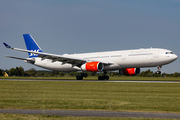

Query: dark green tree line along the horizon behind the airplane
left=0, top=66, right=180, bottom=77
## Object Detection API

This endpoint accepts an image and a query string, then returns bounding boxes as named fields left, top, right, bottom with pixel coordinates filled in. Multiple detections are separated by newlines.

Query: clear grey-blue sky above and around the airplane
left=0, top=0, right=180, bottom=73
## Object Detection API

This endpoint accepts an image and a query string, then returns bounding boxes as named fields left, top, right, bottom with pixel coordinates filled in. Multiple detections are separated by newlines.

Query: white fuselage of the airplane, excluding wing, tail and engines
left=34, top=48, right=177, bottom=72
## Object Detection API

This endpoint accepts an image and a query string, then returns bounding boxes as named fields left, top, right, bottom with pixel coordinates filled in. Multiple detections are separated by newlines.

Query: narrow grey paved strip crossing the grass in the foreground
left=0, top=109, right=180, bottom=119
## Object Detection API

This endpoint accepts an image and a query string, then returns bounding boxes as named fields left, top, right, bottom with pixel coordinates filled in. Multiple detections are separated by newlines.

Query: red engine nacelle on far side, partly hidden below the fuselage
left=119, top=68, right=141, bottom=76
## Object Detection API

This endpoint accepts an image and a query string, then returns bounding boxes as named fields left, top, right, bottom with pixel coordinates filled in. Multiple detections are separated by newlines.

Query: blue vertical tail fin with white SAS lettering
left=23, top=34, right=43, bottom=58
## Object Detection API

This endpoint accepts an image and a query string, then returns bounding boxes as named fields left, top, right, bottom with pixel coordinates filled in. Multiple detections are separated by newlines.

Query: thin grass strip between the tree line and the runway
left=0, top=76, right=180, bottom=81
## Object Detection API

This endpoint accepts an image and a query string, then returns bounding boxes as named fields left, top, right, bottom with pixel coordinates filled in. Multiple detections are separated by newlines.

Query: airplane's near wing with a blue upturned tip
left=3, top=43, right=111, bottom=67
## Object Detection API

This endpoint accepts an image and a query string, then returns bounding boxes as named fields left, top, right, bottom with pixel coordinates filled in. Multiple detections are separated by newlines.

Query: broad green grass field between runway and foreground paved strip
left=0, top=81, right=180, bottom=113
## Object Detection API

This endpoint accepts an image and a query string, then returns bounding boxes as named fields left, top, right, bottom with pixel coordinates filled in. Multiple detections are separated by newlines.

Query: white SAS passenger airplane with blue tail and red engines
left=3, top=34, right=178, bottom=80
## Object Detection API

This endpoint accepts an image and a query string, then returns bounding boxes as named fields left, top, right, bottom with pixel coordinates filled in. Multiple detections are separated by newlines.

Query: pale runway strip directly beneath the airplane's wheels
left=0, top=79, right=180, bottom=83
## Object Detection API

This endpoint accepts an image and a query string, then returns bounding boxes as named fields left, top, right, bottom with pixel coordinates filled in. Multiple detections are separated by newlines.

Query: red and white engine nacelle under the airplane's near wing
left=81, top=61, right=104, bottom=72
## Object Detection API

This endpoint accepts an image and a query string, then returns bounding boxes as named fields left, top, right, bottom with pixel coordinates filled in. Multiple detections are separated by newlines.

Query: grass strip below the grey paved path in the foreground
left=0, top=114, right=177, bottom=120
